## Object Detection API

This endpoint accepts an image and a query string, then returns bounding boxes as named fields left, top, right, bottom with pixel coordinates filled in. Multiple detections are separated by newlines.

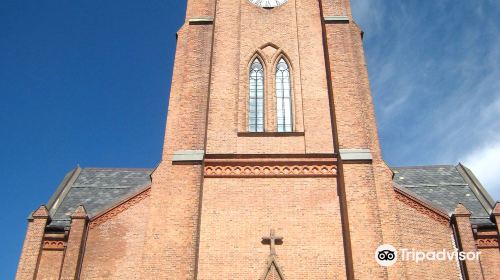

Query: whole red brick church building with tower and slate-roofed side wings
left=16, top=0, right=500, bottom=280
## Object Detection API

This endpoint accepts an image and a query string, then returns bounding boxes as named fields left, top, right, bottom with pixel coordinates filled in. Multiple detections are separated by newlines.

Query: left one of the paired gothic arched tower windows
left=248, top=58, right=264, bottom=132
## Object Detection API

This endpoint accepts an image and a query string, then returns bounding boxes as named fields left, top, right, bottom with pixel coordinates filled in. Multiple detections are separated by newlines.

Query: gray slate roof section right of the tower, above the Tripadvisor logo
left=392, top=165, right=494, bottom=224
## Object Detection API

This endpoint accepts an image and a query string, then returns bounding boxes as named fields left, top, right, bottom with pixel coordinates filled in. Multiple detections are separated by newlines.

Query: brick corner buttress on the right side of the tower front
left=322, top=9, right=405, bottom=279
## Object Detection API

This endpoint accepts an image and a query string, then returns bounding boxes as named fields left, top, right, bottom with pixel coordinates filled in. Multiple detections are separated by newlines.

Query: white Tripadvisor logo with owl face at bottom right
left=375, top=244, right=481, bottom=267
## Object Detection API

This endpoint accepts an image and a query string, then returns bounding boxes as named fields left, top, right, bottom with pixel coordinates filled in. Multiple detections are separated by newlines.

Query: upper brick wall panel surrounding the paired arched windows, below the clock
left=207, top=0, right=333, bottom=154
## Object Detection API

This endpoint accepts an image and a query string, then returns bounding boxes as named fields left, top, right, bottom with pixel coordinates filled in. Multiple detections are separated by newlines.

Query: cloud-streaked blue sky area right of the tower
left=352, top=0, right=500, bottom=200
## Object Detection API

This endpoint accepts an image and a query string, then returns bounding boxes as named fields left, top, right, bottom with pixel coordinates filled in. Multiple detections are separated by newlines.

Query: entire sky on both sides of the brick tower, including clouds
left=0, top=0, right=500, bottom=279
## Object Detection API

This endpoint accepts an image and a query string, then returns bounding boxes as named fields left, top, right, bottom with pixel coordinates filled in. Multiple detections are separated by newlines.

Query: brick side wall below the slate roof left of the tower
left=81, top=198, right=151, bottom=279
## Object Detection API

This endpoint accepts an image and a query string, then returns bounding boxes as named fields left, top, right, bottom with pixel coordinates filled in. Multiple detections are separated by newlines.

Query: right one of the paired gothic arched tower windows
left=276, top=58, right=293, bottom=132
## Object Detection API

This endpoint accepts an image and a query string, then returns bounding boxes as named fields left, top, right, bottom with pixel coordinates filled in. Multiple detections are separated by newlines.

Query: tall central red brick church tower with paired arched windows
left=143, top=0, right=402, bottom=279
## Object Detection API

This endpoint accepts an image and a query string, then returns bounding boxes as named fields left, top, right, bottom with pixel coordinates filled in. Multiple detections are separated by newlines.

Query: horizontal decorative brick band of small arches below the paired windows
left=205, top=159, right=337, bottom=178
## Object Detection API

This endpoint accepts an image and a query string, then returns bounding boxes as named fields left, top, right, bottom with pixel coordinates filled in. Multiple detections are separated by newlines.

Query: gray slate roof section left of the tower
left=48, top=167, right=152, bottom=227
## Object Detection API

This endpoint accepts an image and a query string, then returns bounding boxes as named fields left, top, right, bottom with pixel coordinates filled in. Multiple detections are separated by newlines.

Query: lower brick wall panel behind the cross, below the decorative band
left=198, top=178, right=345, bottom=280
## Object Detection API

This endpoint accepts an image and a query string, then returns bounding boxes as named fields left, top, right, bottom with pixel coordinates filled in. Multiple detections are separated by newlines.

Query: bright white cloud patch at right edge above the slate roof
left=464, top=140, right=500, bottom=201
